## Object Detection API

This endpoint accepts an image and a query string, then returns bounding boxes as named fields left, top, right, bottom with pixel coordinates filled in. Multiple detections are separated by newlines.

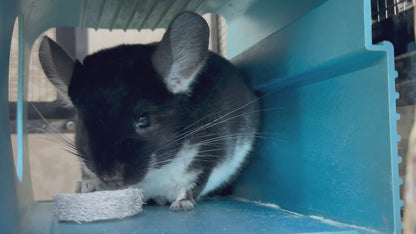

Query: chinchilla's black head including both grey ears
left=39, top=12, right=209, bottom=187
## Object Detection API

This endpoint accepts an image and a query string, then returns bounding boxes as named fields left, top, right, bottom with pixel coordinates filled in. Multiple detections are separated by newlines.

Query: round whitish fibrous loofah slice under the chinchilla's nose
left=53, top=188, right=143, bottom=222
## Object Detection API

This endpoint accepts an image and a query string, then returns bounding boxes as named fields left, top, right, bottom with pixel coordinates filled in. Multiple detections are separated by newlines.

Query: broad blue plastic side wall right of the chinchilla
left=233, top=0, right=401, bottom=232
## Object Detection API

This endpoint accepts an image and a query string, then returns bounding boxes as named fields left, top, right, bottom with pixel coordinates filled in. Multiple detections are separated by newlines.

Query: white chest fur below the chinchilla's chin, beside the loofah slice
left=134, top=142, right=199, bottom=202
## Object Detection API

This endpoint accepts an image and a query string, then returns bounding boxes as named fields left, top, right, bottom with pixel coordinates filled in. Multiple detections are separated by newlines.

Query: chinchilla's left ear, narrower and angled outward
left=39, top=36, right=75, bottom=107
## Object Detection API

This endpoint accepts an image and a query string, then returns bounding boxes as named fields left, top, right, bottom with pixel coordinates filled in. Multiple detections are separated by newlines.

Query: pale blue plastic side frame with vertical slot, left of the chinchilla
left=0, top=0, right=80, bottom=233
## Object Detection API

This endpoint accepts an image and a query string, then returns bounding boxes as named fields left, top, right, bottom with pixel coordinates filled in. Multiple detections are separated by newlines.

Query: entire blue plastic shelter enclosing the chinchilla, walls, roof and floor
left=0, top=0, right=401, bottom=233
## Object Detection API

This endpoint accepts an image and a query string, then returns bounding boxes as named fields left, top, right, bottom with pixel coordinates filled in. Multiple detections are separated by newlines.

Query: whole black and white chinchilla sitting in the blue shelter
left=39, top=12, right=259, bottom=211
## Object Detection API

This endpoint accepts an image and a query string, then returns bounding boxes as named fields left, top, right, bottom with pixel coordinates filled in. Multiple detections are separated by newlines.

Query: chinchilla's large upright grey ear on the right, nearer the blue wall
left=152, top=12, right=209, bottom=94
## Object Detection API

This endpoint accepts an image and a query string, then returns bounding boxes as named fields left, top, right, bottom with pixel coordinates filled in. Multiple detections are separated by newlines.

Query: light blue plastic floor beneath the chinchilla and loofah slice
left=19, top=198, right=372, bottom=233
